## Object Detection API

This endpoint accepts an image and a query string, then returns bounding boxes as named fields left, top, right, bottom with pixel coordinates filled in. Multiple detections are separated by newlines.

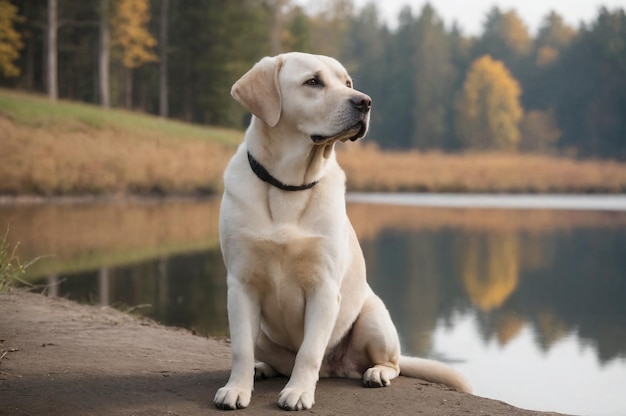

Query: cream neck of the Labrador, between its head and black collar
left=246, top=117, right=335, bottom=191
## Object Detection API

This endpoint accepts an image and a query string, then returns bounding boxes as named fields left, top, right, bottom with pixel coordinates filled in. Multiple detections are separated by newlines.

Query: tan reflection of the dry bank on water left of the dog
left=0, top=199, right=219, bottom=279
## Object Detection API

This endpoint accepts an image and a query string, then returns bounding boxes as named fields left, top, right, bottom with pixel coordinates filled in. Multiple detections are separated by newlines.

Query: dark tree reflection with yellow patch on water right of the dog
left=362, top=226, right=626, bottom=362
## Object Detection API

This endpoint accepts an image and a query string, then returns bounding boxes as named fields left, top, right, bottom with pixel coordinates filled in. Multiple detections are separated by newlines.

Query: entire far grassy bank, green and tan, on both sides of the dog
left=0, top=90, right=626, bottom=196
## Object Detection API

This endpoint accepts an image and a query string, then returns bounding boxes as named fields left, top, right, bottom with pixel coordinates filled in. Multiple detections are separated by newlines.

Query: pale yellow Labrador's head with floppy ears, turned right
left=231, top=52, right=372, bottom=144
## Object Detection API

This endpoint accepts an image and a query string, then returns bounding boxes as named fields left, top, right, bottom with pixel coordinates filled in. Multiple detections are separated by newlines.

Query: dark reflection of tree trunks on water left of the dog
left=39, top=249, right=228, bottom=336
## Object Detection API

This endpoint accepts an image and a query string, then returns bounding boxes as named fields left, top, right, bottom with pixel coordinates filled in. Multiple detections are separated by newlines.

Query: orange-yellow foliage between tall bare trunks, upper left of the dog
left=111, top=0, right=157, bottom=68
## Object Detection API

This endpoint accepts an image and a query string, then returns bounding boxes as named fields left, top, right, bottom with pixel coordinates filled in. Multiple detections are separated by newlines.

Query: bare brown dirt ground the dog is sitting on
left=0, top=291, right=564, bottom=416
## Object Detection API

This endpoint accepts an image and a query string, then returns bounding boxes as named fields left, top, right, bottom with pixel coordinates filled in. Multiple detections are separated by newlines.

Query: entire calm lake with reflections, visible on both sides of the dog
left=0, top=194, right=626, bottom=415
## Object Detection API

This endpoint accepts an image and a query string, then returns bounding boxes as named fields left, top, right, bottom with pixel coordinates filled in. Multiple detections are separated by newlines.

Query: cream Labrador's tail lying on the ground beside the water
left=400, top=355, right=472, bottom=393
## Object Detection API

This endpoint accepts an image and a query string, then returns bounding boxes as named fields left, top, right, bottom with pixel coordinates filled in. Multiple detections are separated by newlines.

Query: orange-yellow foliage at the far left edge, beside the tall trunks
left=0, top=0, right=24, bottom=77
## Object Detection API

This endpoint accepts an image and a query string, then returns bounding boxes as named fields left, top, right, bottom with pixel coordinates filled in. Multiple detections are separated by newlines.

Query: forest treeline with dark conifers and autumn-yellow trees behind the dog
left=0, top=0, right=626, bottom=160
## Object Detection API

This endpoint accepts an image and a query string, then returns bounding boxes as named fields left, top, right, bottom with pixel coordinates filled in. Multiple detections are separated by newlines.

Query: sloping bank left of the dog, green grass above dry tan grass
left=0, top=90, right=242, bottom=195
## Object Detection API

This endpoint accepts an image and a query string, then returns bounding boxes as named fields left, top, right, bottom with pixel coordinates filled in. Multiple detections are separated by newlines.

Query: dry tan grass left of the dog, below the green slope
left=0, top=116, right=232, bottom=195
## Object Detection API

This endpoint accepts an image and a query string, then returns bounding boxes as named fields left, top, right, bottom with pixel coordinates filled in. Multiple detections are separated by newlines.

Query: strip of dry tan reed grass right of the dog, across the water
left=338, top=143, right=626, bottom=193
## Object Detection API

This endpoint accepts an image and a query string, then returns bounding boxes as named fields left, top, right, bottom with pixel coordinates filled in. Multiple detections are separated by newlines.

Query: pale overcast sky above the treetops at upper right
left=346, top=0, right=626, bottom=35
